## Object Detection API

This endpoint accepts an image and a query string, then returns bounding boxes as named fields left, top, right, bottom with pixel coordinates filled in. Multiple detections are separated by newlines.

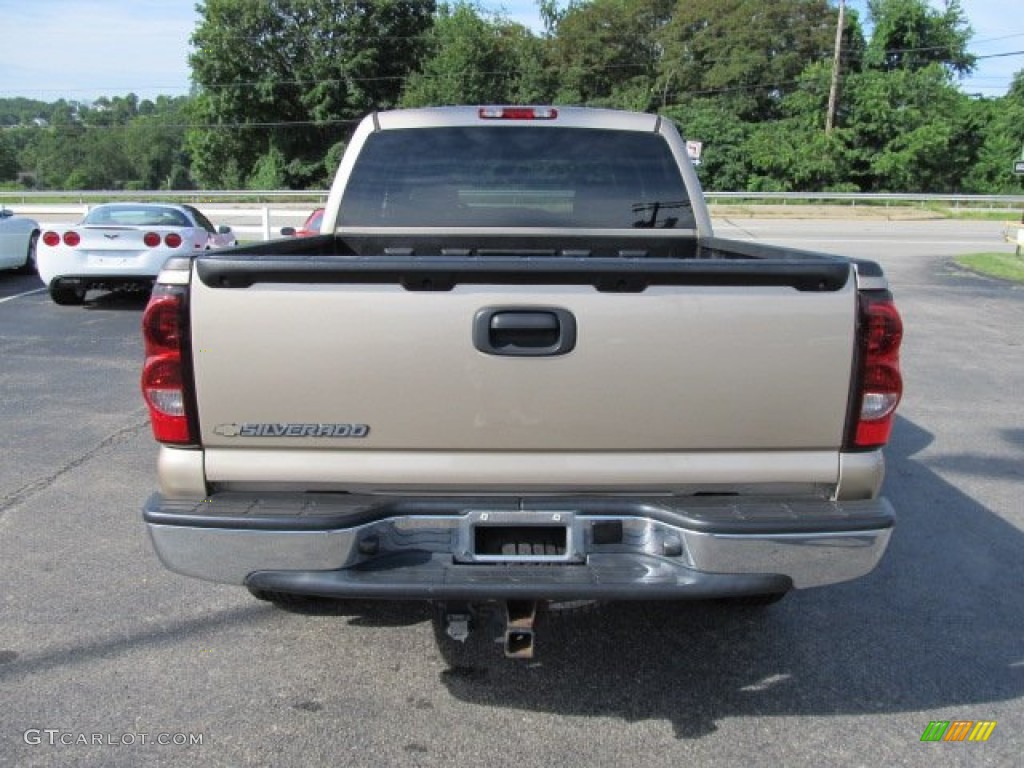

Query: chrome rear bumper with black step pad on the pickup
left=143, top=494, right=894, bottom=599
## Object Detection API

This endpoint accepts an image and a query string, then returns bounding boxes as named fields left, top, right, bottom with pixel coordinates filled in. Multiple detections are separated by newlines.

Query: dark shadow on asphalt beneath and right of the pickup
left=280, top=420, right=1024, bottom=738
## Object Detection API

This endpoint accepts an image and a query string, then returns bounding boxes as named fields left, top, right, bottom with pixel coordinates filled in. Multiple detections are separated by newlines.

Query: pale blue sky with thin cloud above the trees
left=0, top=0, right=1024, bottom=101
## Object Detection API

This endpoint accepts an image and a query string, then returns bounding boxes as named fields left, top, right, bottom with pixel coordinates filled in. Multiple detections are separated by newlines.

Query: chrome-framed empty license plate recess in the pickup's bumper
left=456, top=511, right=584, bottom=563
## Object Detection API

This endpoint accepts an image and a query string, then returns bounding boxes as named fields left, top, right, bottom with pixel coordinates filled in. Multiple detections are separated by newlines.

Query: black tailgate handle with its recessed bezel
left=473, top=307, right=577, bottom=357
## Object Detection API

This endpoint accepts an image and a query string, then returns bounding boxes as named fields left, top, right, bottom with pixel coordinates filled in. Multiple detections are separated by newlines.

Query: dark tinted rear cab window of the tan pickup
left=339, top=126, right=695, bottom=229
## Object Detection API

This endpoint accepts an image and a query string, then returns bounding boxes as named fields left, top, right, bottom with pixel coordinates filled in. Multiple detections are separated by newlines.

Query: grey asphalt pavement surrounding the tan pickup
left=0, top=218, right=1024, bottom=767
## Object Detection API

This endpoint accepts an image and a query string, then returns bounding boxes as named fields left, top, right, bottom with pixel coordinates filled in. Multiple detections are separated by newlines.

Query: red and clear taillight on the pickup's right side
left=849, top=291, right=903, bottom=450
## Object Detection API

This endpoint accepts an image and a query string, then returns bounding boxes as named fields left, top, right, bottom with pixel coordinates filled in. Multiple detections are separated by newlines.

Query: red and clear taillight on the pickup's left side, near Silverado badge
left=142, top=285, right=195, bottom=444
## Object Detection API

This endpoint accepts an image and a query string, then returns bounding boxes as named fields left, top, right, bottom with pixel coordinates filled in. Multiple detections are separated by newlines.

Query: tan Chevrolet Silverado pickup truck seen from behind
left=141, top=106, right=902, bottom=656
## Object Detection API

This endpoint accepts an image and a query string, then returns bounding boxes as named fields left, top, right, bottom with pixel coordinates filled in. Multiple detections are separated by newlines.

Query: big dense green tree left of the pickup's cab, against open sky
left=186, top=0, right=434, bottom=187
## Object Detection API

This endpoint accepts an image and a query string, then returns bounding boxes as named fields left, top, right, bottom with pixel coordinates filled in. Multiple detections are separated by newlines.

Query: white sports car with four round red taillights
left=36, top=203, right=236, bottom=304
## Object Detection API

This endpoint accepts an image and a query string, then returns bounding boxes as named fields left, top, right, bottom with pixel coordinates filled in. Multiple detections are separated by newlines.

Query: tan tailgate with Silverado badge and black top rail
left=190, top=257, right=856, bottom=479
